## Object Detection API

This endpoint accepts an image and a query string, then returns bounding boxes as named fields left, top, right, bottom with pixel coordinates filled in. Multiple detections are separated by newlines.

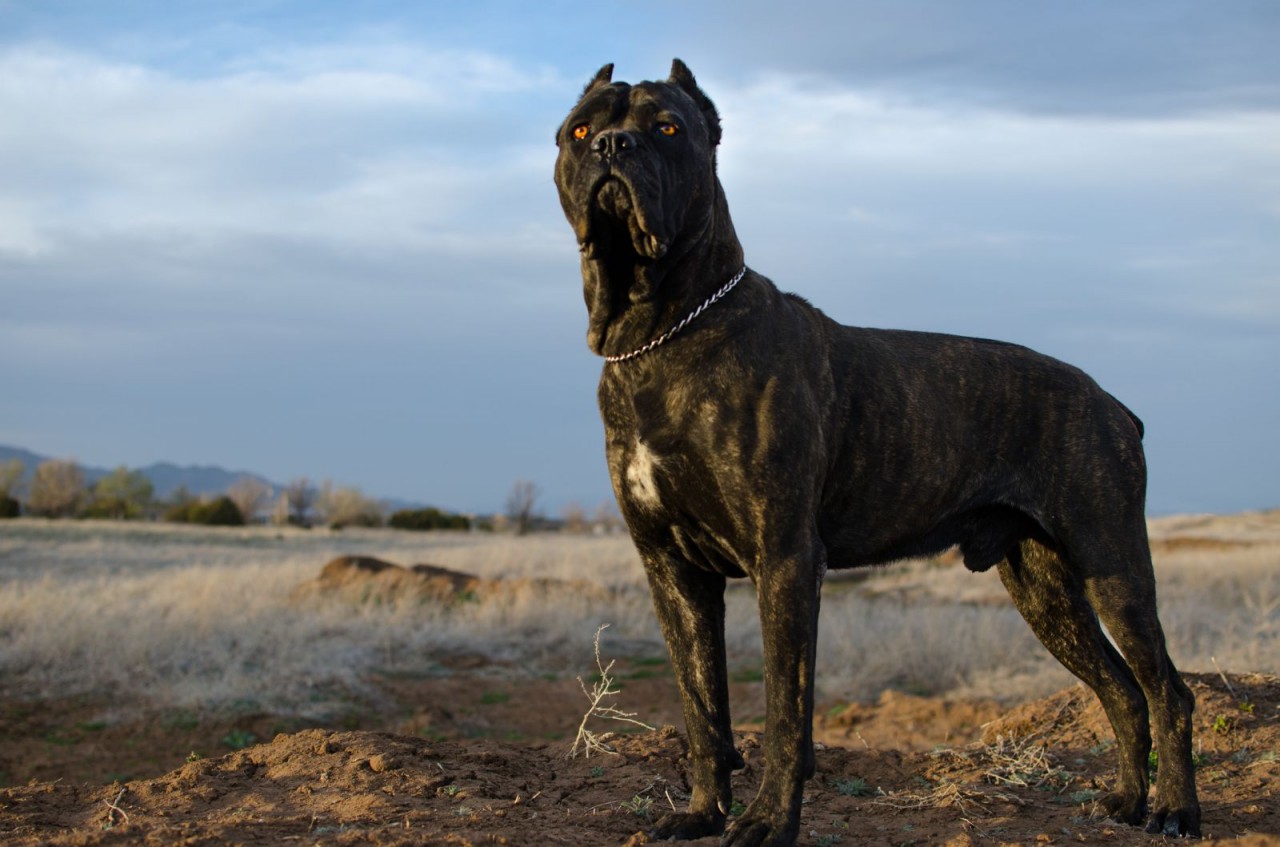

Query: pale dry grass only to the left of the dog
left=0, top=521, right=657, bottom=713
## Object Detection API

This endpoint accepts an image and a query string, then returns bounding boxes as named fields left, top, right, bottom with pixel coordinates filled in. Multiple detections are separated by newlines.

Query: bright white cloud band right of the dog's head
left=704, top=73, right=1280, bottom=330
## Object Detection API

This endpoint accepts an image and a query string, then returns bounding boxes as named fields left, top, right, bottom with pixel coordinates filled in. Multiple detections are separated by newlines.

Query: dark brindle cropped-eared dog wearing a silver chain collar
left=556, top=59, right=1201, bottom=847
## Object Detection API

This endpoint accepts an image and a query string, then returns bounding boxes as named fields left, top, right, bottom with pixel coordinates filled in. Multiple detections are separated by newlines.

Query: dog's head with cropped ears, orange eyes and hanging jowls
left=556, top=59, right=721, bottom=352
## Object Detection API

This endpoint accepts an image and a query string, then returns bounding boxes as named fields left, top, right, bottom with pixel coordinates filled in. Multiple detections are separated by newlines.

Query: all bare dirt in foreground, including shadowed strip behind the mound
left=0, top=667, right=1280, bottom=847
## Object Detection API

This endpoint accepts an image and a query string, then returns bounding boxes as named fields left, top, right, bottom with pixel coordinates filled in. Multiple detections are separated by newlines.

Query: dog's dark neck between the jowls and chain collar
left=582, top=180, right=742, bottom=356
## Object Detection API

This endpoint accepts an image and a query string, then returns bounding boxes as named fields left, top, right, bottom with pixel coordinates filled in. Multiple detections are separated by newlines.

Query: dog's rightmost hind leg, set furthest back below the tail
left=1085, top=547, right=1201, bottom=837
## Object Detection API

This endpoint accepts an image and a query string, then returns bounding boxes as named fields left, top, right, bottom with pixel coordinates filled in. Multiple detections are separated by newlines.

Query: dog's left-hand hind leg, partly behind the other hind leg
left=998, top=539, right=1151, bottom=825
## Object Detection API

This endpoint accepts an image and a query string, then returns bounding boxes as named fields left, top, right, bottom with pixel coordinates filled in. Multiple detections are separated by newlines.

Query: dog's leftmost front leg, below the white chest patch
left=644, top=551, right=742, bottom=839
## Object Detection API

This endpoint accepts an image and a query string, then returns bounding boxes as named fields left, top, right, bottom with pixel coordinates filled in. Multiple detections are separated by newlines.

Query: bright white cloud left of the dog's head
left=0, top=47, right=565, bottom=253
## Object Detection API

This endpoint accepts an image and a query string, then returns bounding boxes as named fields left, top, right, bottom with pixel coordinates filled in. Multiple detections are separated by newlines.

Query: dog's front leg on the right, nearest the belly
left=723, top=542, right=826, bottom=847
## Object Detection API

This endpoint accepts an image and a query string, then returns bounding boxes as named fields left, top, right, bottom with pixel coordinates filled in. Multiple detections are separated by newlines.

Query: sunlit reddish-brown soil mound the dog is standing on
left=0, top=675, right=1280, bottom=847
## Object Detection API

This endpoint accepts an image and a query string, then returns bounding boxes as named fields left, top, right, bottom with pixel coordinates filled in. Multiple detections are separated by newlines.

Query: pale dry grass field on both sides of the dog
left=0, top=513, right=1280, bottom=714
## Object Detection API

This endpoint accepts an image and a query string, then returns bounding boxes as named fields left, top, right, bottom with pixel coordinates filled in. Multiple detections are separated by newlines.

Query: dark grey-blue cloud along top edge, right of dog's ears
left=684, top=0, right=1280, bottom=116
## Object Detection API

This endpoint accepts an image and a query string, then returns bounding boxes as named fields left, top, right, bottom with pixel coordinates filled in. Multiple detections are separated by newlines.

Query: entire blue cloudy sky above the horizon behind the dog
left=0, top=0, right=1280, bottom=516
